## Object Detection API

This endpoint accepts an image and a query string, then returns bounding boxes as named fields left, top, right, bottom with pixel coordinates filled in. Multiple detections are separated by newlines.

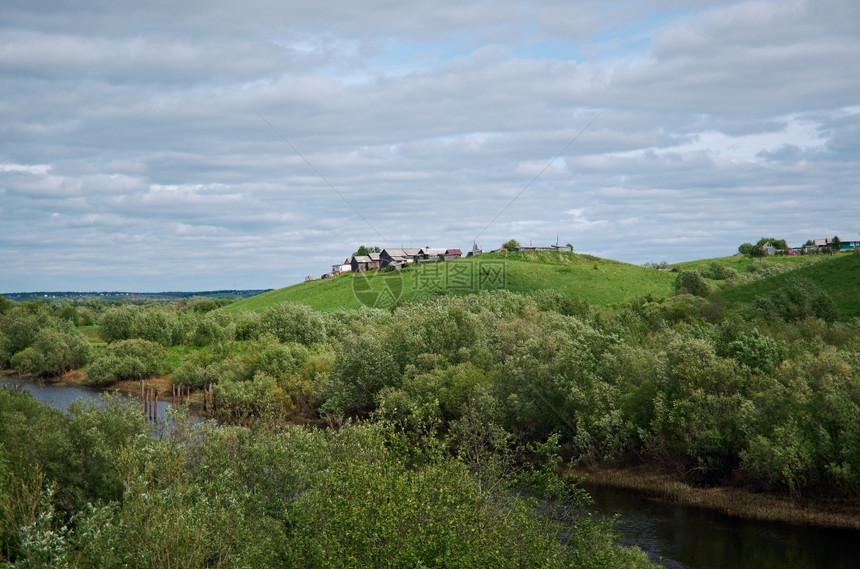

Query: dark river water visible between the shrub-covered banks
left=0, top=378, right=860, bottom=569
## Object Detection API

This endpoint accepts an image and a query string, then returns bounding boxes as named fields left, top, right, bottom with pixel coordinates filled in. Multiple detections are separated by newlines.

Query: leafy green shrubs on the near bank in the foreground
left=0, top=390, right=651, bottom=569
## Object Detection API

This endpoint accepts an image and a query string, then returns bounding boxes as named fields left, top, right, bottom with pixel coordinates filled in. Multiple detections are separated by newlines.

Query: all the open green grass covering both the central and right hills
left=227, top=252, right=860, bottom=320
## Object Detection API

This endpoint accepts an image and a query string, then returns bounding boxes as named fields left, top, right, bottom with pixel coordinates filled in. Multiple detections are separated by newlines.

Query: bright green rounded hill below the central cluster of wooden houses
left=229, top=252, right=675, bottom=311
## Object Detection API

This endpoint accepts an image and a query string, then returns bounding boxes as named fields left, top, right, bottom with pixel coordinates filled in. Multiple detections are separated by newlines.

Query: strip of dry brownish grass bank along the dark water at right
left=573, top=466, right=860, bottom=529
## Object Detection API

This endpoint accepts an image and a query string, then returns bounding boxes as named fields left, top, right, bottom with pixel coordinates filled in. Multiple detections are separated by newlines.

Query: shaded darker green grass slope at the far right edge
left=718, top=253, right=860, bottom=320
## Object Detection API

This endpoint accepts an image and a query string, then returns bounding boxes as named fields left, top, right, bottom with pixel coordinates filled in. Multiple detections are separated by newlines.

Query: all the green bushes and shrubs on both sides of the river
left=0, top=255, right=860, bottom=567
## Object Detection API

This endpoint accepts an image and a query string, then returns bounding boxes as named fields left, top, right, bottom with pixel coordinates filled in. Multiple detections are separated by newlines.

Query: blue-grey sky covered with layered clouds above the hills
left=0, top=0, right=860, bottom=293
